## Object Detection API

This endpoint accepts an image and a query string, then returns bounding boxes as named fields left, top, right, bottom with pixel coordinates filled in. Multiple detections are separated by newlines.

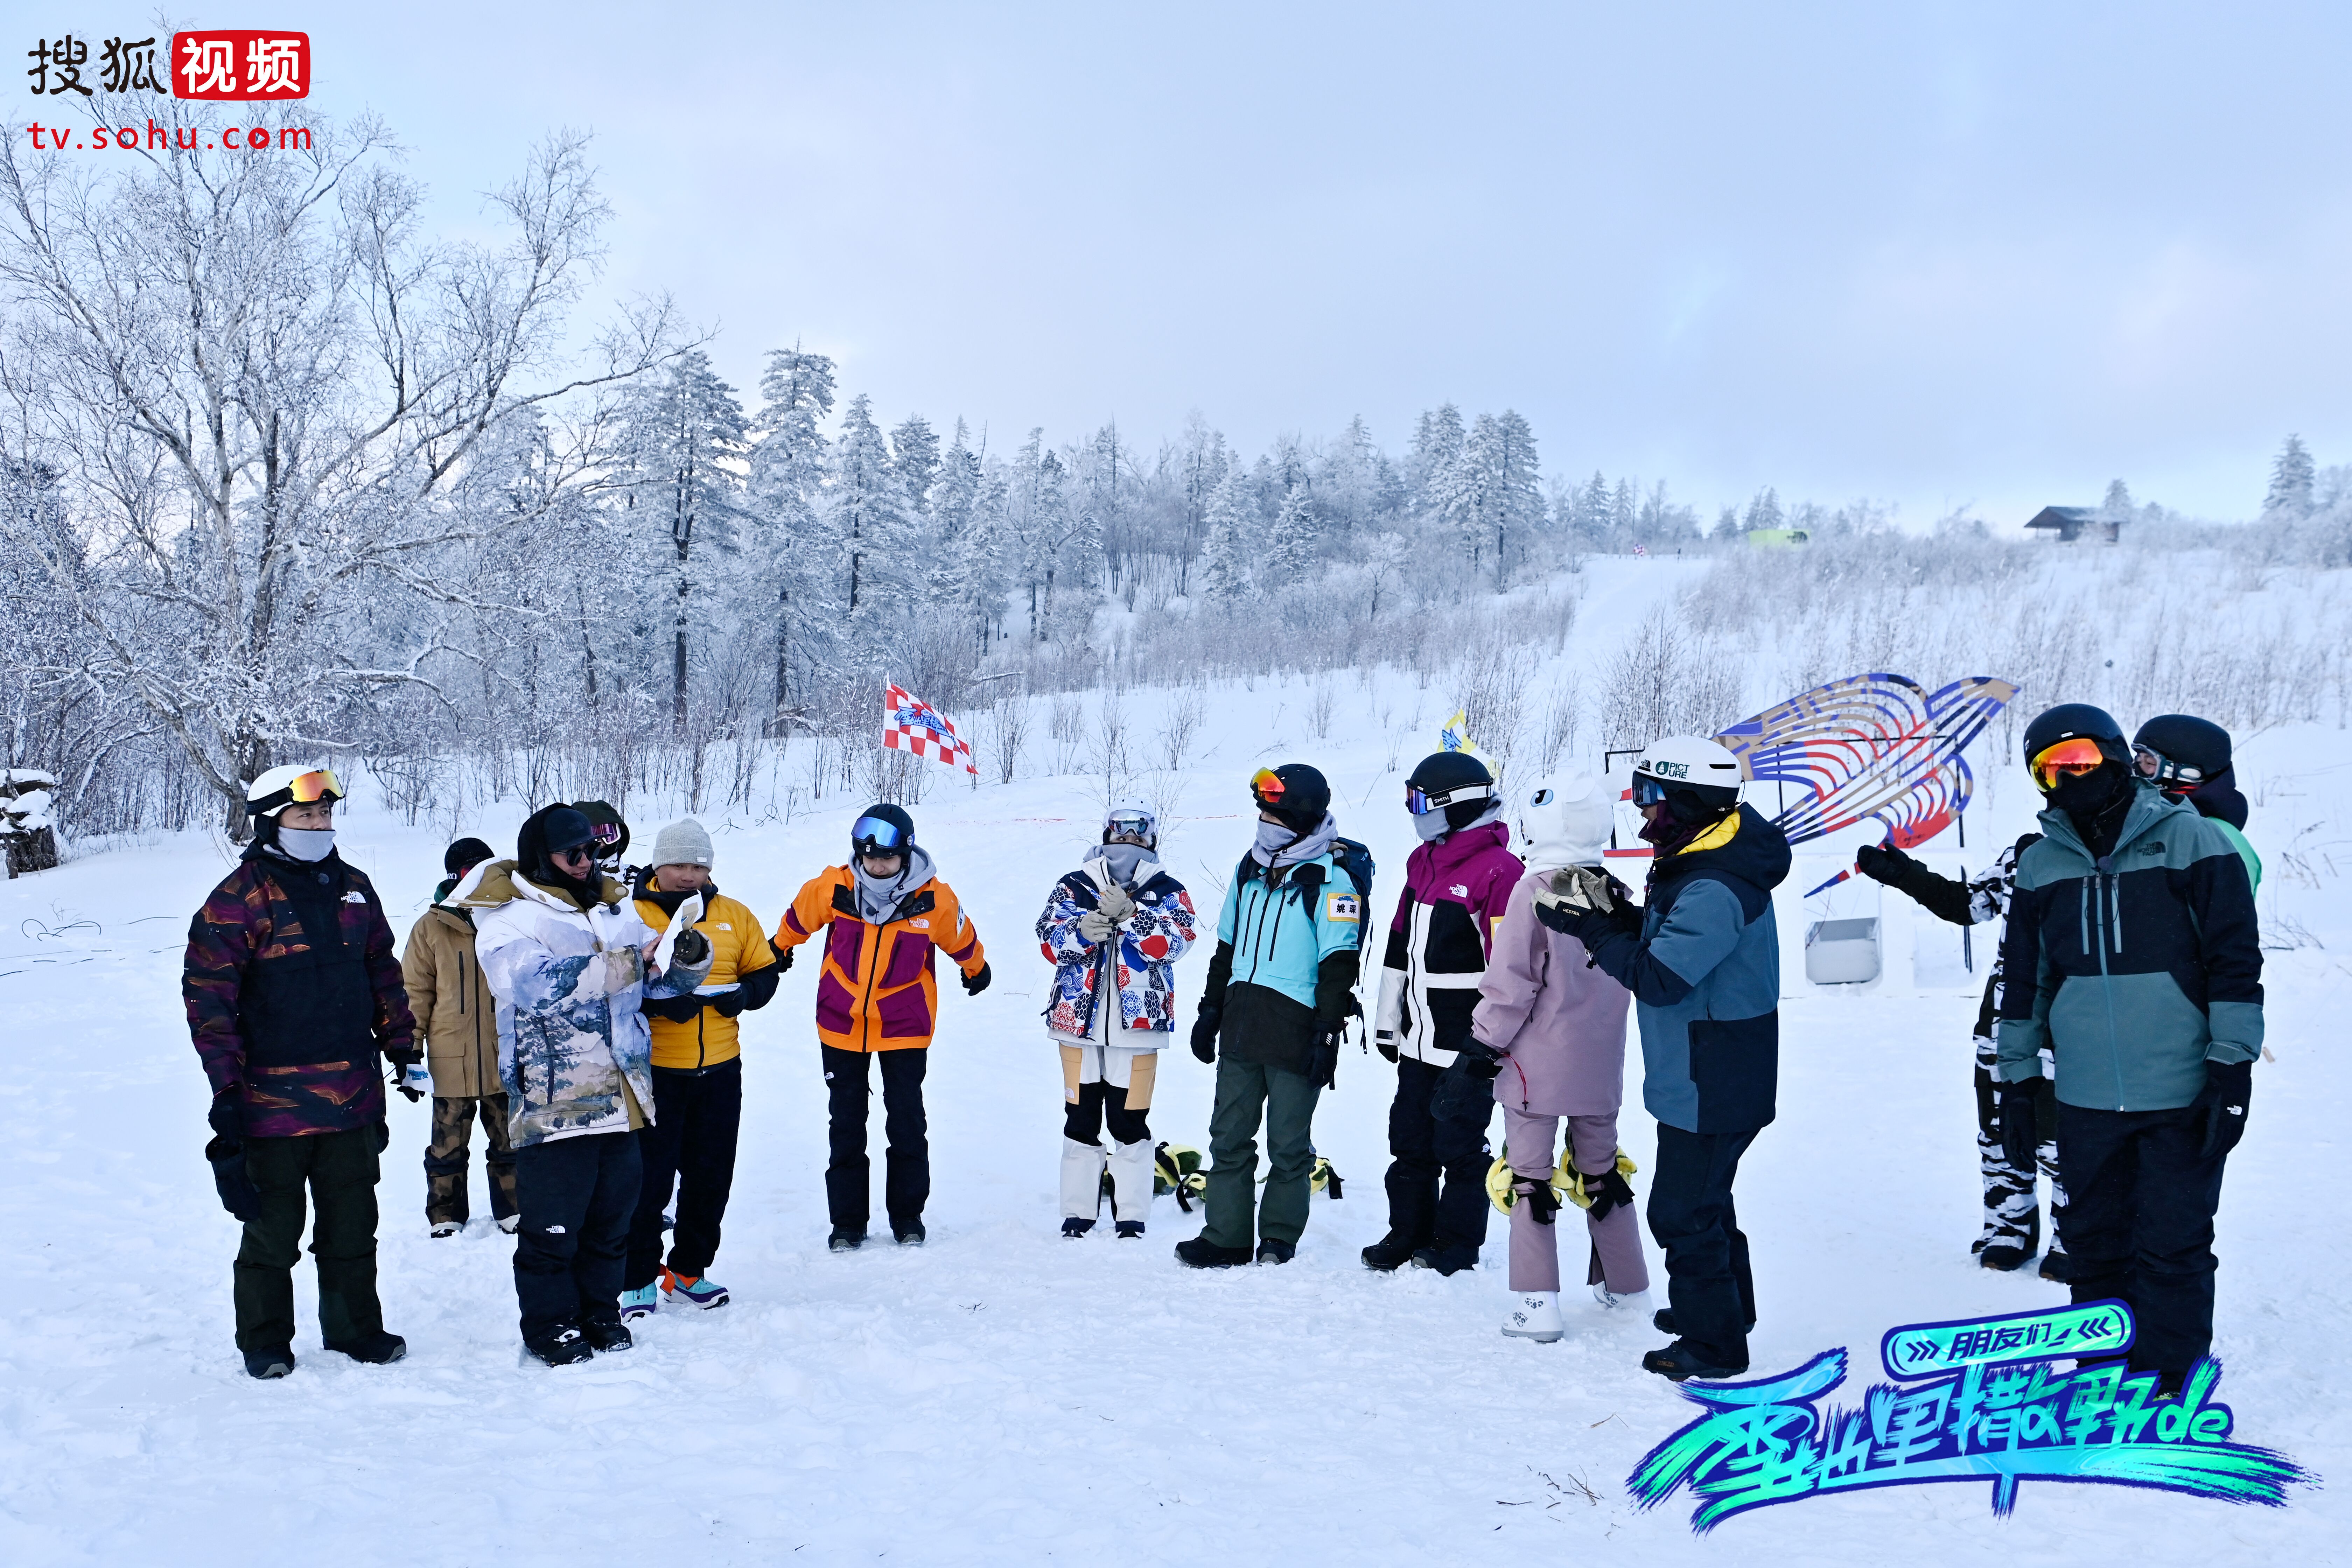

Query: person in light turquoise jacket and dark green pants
left=1176, top=762, right=1364, bottom=1269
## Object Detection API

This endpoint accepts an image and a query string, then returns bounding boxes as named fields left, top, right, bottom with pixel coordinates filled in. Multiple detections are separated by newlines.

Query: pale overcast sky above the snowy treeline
left=289, top=0, right=2352, bottom=524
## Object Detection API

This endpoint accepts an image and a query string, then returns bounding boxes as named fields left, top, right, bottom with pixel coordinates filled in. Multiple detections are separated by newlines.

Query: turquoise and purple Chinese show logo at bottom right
left=1625, top=1300, right=2319, bottom=1535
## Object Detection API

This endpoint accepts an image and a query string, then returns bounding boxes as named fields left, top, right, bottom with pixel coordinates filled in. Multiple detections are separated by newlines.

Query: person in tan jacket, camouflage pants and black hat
left=400, top=839, right=515, bottom=1237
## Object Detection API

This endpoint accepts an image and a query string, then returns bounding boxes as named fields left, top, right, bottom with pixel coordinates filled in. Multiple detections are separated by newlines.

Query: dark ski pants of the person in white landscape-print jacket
left=515, top=1131, right=644, bottom=1340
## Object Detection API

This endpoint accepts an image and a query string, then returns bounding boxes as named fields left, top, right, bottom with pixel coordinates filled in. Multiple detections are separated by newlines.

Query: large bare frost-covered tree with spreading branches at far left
left=0, top=115, right=670, bottom=834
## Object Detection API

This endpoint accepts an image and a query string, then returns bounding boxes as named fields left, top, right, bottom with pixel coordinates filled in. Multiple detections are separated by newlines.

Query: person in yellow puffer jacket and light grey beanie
left=621, top=816, right=790, bottom=1319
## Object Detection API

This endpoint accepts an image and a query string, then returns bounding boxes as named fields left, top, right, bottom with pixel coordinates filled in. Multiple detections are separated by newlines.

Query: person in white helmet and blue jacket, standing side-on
left=1536, top=736, right=1790, bottom=1382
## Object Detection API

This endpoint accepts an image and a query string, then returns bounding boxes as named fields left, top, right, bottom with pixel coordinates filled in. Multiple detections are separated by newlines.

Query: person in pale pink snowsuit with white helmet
left=1470, top=774, right=1649, bottom=1340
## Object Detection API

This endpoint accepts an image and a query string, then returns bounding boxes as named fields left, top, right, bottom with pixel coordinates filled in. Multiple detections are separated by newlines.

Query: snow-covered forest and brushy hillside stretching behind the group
left=0, top=118, right=2352, bottom=839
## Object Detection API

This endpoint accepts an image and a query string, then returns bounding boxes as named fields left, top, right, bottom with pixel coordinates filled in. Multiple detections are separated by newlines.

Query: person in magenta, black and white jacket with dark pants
left=1364, top=752, right=1522, bottom=1274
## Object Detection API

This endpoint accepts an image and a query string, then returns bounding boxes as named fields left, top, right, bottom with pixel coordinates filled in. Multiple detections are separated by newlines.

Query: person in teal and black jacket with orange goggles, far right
left=1999, top=703, right=2263, bottom=1394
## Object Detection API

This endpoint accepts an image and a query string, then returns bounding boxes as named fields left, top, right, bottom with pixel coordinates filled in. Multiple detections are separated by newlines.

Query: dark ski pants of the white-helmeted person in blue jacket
left=1649, top=1121, right=1759, bottom=1368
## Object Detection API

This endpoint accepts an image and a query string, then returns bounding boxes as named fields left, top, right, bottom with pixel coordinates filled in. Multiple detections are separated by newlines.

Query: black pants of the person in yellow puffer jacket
left=621, top=1056, right=743, bottom=1290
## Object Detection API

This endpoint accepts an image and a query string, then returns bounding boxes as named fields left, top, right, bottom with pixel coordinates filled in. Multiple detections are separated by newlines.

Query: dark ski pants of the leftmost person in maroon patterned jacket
left=233, top=1121, right=386, bottom=1349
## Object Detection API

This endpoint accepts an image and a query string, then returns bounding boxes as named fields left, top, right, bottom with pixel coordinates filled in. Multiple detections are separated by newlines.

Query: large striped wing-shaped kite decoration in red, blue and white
left=1717, top=672, right=2018, bottom=896
